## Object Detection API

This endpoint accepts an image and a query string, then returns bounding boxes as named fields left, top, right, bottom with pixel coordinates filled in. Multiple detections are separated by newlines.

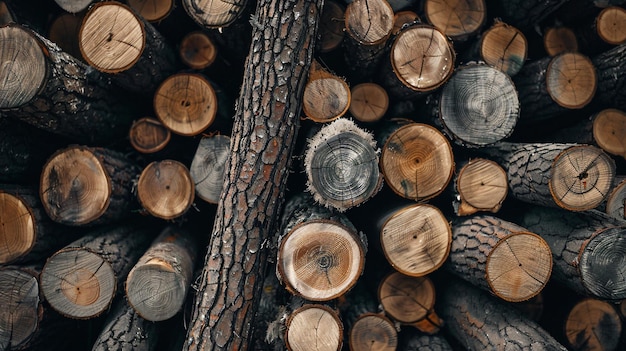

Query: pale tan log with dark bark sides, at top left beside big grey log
left=78, top=1, right=177, bottom=96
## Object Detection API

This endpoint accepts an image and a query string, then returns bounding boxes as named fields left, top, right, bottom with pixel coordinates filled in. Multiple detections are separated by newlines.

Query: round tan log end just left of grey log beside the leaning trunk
left=137, top=160, right=195, bottom=219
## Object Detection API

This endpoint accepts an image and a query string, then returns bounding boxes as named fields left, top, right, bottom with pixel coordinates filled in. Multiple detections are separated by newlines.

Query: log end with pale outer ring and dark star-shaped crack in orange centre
left=278, top=220, right=365, bottom=301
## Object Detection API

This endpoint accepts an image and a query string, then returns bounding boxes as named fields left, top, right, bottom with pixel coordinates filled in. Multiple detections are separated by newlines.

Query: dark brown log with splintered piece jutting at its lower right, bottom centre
left=378, top=272, right=444, bottom=334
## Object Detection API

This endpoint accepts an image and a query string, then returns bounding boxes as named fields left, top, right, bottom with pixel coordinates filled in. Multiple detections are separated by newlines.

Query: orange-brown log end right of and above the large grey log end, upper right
left=546, top=52, right=598, bottom=109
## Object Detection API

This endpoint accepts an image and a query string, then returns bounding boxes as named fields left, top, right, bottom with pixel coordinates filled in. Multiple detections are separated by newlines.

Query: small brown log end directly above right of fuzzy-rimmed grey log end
left=349, top=83, right=389, bottom=123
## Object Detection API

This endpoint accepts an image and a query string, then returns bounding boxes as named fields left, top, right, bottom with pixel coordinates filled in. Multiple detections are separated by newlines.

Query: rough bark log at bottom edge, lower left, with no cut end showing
left=91, top=297, right=159, bottom=351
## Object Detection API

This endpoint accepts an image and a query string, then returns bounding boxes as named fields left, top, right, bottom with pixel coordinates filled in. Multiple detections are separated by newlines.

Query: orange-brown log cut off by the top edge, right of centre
left=423, top=0, right=487, bottom=41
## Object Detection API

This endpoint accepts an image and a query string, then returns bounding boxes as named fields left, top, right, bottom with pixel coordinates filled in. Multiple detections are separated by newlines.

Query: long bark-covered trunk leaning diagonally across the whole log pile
left=179, top=0, right=322, bottom=350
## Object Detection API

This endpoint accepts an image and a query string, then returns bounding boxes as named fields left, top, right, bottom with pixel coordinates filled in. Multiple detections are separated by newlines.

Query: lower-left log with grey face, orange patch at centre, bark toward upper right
left=41, top=224, right=151, bottom=319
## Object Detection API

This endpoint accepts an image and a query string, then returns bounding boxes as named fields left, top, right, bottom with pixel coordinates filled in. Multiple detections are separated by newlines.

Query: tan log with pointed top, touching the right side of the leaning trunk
left=302, top=61, right=351, bottom=123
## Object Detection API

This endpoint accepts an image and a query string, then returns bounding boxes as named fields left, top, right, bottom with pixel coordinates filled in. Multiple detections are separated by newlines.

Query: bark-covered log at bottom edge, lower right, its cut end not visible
left=438, top=279, right=567, bottom=351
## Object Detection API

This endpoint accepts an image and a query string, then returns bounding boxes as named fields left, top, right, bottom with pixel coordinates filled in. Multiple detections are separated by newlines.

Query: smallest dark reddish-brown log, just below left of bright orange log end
left=128, top=117, right=172, bottom=154
